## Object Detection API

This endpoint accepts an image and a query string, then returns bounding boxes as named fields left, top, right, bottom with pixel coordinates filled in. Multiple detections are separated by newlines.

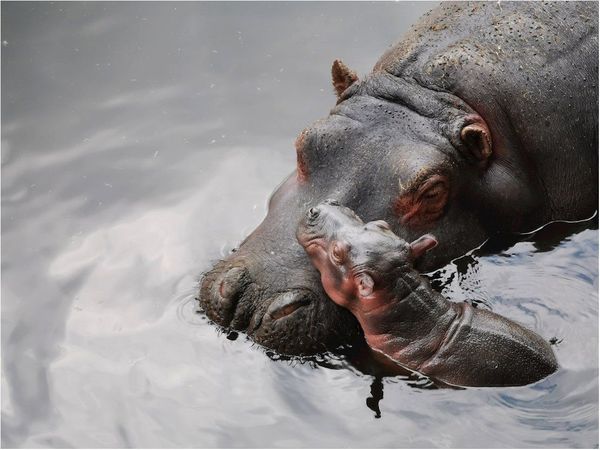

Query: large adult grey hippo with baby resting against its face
left=200, top=2, right=598, bottom=354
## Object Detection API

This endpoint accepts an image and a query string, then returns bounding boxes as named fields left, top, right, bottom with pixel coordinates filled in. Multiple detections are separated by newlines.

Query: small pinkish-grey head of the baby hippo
left=296, top=200, right=437, bottom=314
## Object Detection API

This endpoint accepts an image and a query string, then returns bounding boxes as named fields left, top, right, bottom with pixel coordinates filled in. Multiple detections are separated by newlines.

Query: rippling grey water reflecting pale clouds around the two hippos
left=2, top=2, right=598, bottom=447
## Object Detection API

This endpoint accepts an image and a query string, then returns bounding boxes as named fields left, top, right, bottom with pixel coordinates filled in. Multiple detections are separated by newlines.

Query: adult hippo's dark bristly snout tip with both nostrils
left=199, top=252, right=360, bottom=355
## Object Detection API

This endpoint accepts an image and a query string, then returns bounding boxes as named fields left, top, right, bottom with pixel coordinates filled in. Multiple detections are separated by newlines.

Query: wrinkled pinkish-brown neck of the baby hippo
left=355, top=268, right=460, bottom=368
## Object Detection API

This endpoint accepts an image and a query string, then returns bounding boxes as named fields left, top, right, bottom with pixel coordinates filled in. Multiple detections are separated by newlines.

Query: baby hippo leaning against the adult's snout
left=297, top=200, right=557, bottom=386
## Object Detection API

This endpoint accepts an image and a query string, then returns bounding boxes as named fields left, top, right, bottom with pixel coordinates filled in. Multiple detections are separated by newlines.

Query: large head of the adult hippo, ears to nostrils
left=200, top=61, right=502, bottom=354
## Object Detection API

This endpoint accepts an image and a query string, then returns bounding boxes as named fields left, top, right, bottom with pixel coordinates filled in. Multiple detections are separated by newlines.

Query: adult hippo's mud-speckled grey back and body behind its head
left=374, top=2, right=598, bottom=223
